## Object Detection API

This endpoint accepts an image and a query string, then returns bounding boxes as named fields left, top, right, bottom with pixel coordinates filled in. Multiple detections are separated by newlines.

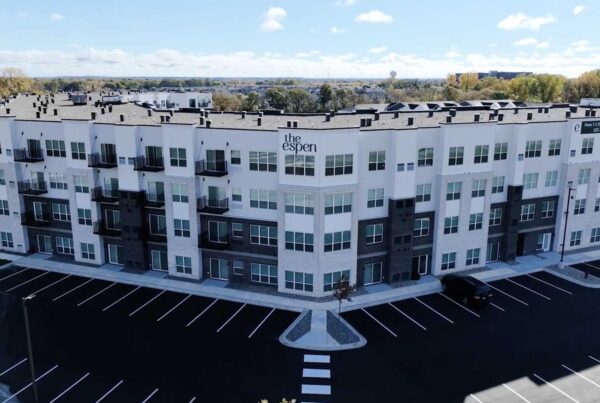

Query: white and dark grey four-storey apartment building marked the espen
left=0, top=94, right=600, bottom=297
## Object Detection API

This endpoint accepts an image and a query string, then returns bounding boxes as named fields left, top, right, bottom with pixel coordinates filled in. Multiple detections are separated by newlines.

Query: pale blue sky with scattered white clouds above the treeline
left=0, top=0, right=600, bottom=78
